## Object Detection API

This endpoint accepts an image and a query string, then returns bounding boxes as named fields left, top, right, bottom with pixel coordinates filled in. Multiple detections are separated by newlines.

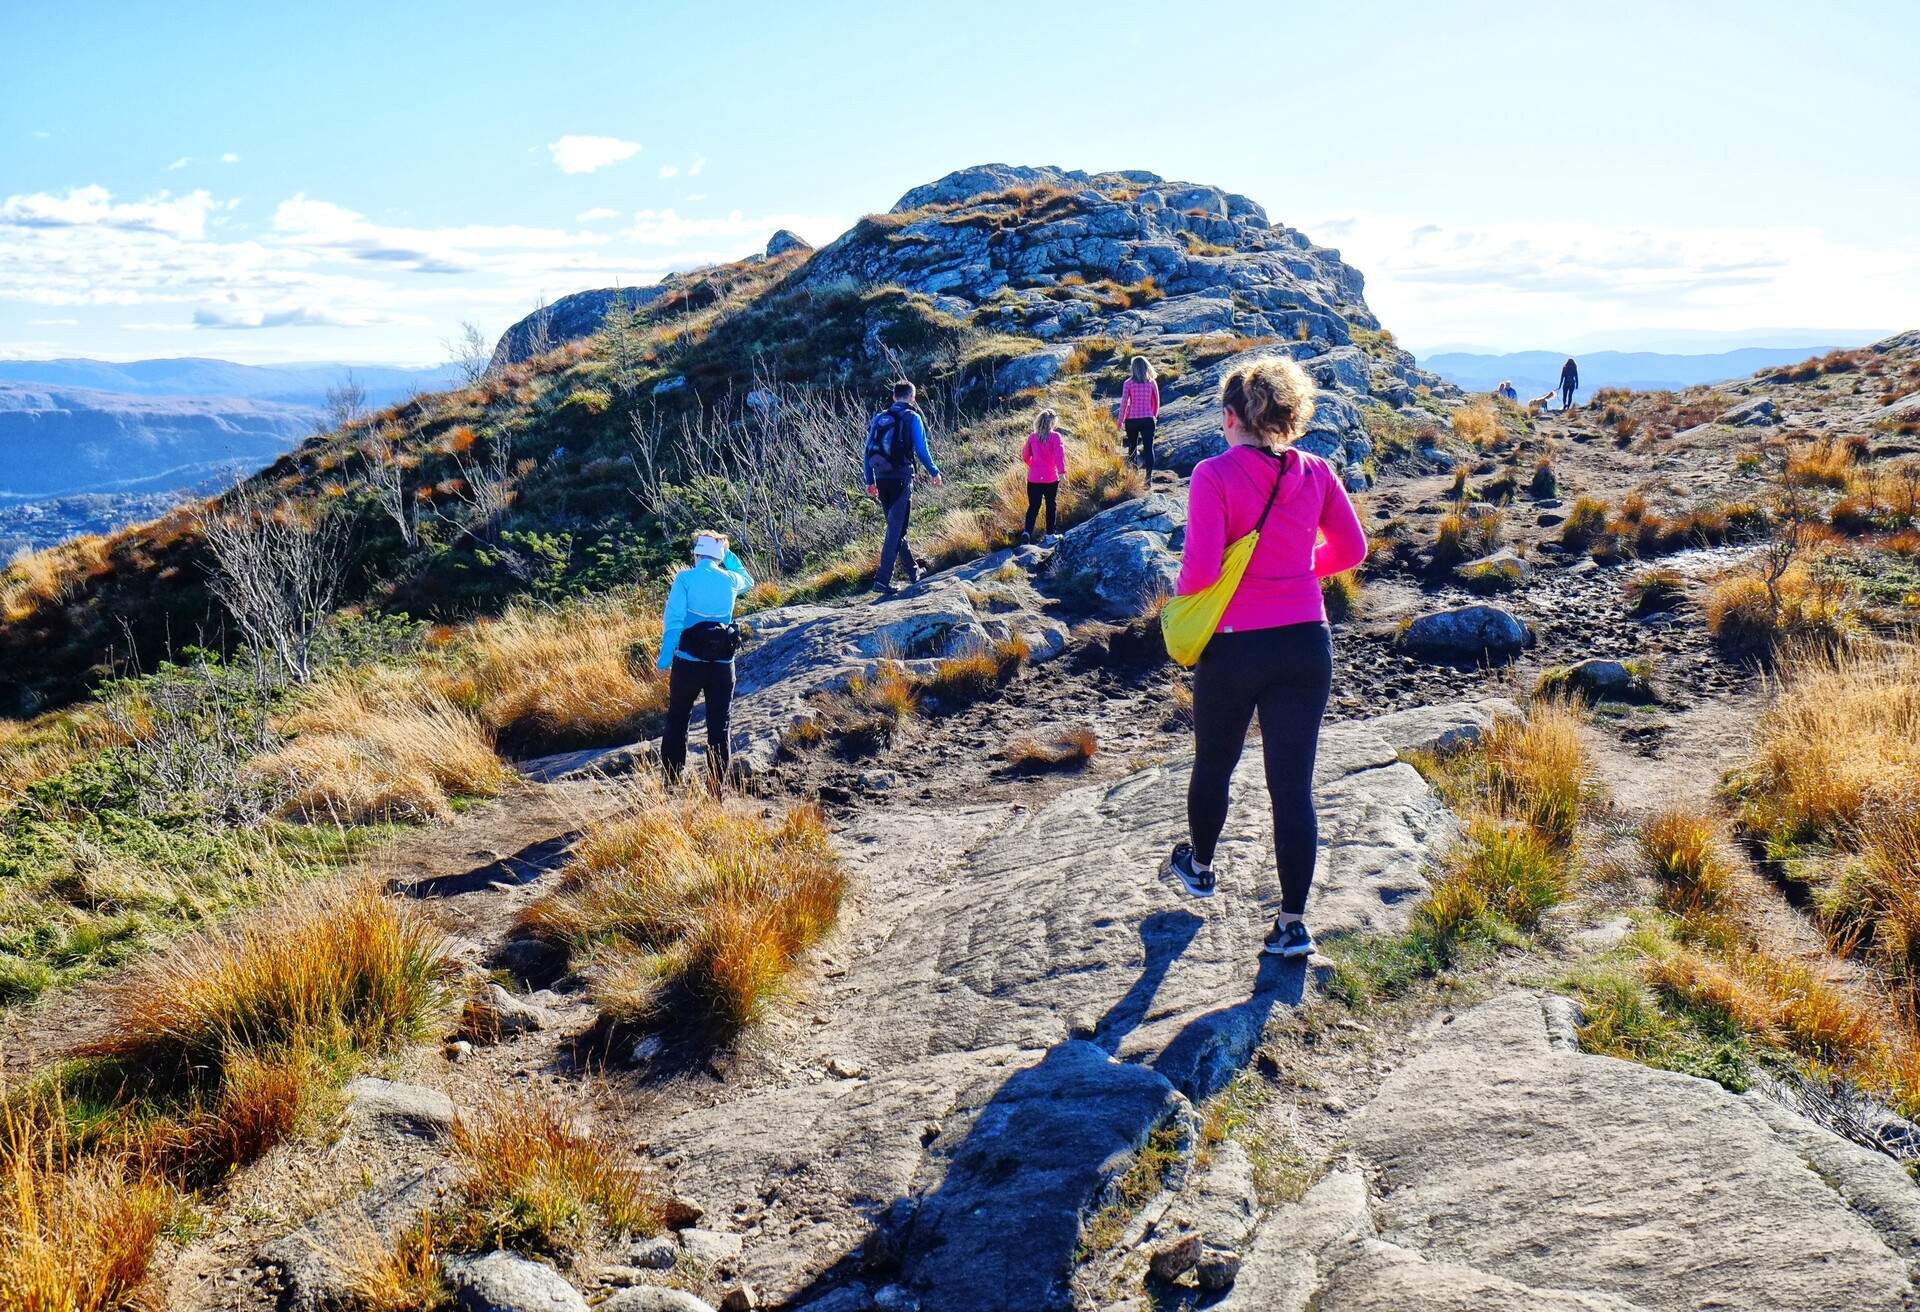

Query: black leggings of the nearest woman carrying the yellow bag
left=1187, top=624, right=1332, bottom=916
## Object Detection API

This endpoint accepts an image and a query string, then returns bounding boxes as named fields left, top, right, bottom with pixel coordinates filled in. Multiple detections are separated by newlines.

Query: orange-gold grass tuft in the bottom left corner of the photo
left=0, top=1099, right=177, bottom=1312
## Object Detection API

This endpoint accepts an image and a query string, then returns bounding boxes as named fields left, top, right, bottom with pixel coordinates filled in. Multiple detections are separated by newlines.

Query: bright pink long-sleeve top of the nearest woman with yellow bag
left=1175, top=446, right=1367, bottom=634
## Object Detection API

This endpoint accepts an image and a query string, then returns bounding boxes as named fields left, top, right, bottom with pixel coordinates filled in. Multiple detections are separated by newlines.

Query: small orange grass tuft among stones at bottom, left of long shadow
left=445, top=1091, right=666, bottom=1270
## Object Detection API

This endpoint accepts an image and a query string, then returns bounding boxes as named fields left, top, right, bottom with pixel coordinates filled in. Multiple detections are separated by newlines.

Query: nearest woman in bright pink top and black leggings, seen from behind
left=1171, top=357, right=1367, bottom=957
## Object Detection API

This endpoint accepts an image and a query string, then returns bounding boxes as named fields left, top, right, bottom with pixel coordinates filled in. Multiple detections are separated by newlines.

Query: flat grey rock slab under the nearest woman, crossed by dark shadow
left=655, top=705, right=1494, bottom=1312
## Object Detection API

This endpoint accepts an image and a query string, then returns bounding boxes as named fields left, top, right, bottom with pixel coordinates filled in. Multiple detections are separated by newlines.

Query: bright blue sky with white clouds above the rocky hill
left=0, top=0, right=1920, bottom=363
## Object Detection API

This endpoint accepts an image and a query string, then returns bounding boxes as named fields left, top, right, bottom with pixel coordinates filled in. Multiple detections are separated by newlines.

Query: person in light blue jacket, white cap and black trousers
left=660, top=532, right=753, bottom=784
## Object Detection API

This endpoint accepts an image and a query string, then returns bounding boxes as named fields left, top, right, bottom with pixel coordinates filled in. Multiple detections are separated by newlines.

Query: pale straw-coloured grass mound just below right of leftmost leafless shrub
left=248, top=672, right=513, bottom=824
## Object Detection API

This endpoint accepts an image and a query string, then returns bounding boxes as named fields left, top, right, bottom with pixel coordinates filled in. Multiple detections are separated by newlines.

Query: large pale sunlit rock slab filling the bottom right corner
left=1217, top=993, right=1914, bottom=1312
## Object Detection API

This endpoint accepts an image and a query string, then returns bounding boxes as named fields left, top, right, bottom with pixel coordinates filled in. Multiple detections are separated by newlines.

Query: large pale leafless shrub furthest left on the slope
left=200, top=484, right=348, bottom=684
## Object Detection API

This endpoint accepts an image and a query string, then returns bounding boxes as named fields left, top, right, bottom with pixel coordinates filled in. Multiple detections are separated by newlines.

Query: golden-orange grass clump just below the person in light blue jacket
left=522, top=784, right=845, bottom=1028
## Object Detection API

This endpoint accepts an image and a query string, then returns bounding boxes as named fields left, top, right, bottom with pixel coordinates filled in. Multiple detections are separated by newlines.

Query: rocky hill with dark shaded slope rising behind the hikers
left=0, top=165, right=1450, bottom=709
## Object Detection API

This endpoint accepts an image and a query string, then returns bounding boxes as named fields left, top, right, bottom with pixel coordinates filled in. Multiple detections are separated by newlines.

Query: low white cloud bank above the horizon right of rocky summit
left=1302, top=213, right=1920, bottom=350
